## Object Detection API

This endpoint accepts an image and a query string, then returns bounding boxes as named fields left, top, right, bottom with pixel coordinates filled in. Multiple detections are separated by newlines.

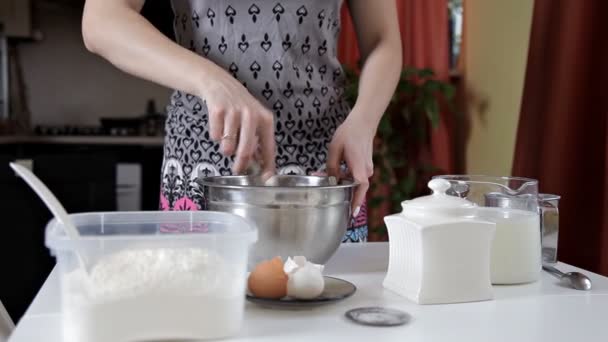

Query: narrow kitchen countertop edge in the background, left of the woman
left=0, top=135, right=164, bottom=146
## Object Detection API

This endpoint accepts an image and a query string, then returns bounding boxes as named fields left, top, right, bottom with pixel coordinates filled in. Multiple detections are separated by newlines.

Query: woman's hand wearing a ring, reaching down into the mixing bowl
left=199, top=67, right=276, bottom=177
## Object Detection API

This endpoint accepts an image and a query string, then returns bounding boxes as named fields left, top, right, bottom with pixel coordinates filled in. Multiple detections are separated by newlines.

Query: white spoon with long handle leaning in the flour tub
left=9, top=163, right=86, bottom=269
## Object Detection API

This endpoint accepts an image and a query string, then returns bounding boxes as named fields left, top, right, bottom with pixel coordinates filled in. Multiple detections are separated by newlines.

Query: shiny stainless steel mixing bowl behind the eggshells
left=197, top=176, right=357, bottom=264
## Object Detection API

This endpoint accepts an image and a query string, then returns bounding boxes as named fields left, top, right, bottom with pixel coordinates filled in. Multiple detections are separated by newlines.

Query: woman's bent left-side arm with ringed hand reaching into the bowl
left=82, top=0, right=275, bottom=173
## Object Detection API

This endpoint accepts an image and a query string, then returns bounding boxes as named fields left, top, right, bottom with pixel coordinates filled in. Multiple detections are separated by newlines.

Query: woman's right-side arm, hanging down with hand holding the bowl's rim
left=327, top=0, right=402, bottom=216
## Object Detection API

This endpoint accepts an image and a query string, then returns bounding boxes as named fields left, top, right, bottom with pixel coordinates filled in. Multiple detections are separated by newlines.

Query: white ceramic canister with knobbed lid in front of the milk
left=383, top=179, right=496, bottom=304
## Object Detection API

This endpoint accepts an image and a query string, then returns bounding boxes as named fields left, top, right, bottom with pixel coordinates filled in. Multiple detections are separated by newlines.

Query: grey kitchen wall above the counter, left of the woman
left=19, top=0, right=170, bottom=125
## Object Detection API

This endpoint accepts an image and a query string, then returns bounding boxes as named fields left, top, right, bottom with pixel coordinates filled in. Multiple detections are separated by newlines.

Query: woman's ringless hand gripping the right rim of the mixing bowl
left=327, top=113, right=376, bottom=216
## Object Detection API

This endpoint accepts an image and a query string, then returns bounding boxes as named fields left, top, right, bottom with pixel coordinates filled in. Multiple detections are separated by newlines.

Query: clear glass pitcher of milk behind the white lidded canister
left=437, top=175, right=542, bottom=284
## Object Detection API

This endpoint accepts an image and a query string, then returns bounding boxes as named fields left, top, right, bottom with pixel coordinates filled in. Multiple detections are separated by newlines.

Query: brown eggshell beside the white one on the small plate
left=247, top=257, right=287, bottom=298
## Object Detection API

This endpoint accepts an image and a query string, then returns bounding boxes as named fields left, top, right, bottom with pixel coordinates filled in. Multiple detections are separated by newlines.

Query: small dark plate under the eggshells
left=247, top=276, right=357, bottom=309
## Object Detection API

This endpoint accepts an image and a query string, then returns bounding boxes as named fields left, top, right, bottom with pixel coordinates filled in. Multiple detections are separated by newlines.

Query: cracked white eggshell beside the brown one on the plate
left=284, top=256, right=325, bottom=299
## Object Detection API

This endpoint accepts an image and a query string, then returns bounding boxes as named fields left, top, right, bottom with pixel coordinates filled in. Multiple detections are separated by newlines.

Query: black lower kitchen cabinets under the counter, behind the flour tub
left=0, top=137, right=162, bottom=321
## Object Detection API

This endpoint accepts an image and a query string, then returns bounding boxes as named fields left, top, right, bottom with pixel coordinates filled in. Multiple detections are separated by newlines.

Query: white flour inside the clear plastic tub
left=62, top=248, right=245, bottom=342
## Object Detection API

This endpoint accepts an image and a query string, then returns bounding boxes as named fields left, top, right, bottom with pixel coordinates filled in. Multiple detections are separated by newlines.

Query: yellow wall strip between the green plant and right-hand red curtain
left=464, top=0, right=534, bottom=175
